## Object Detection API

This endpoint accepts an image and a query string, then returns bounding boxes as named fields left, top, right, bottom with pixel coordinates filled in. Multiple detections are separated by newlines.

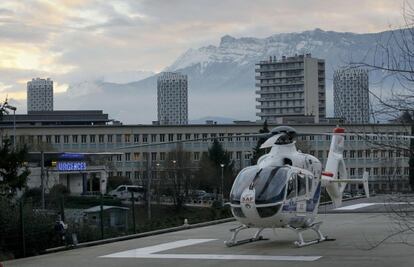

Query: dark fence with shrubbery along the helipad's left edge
left=0, top=194, right=231, bottom=260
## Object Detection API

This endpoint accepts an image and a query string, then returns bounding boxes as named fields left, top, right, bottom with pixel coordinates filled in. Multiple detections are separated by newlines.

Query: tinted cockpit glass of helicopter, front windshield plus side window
left=230, top=166, right=290, bottom=204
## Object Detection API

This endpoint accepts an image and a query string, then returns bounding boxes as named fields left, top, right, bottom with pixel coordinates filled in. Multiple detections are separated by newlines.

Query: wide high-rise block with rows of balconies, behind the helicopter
left=256, top=54, right=326, bottom=123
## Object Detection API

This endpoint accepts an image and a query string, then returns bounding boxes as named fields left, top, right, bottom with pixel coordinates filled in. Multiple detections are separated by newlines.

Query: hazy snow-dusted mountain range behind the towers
left=55, top=29, right=390, bottom=123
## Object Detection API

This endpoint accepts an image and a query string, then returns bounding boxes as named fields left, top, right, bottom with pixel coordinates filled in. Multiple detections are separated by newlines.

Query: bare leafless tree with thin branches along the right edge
left=349, top=1, right=414, bottom=247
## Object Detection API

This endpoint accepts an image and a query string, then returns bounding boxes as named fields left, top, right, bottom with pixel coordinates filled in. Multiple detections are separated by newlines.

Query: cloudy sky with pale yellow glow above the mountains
left=0, top=0, right=409, bottom=119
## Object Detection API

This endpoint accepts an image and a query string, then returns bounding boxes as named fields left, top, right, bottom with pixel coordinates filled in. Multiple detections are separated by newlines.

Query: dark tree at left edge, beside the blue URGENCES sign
left=0, top=139, right=30, bottom=196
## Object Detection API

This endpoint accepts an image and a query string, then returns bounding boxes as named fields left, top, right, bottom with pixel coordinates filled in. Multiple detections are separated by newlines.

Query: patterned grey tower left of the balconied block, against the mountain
left=157, top=72, right=188, bottom=125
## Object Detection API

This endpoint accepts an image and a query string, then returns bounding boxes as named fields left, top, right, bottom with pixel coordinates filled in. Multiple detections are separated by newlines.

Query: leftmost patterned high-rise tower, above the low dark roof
left=27, top=78, right=53, bottom=112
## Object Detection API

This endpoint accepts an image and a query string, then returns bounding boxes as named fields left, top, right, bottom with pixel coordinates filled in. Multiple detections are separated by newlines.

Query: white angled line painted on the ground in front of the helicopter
left=101, top=239, right=321, bottom=261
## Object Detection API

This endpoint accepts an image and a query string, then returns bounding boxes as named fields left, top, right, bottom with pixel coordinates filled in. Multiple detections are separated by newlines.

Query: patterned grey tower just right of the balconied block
left=333, top=69, right=370, bottom=123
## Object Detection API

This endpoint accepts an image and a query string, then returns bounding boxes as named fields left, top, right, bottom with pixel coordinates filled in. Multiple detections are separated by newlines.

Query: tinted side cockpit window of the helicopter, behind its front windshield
left=253, top=166, right=290, bottom=204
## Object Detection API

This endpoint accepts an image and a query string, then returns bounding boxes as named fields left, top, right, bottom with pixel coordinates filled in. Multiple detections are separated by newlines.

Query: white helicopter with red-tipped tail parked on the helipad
left=225, top=126, right=369, bottom=247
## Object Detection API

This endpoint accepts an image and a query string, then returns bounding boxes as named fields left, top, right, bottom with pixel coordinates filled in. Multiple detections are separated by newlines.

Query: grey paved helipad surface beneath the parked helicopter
left=4, top=199, right=414, bottom=267
